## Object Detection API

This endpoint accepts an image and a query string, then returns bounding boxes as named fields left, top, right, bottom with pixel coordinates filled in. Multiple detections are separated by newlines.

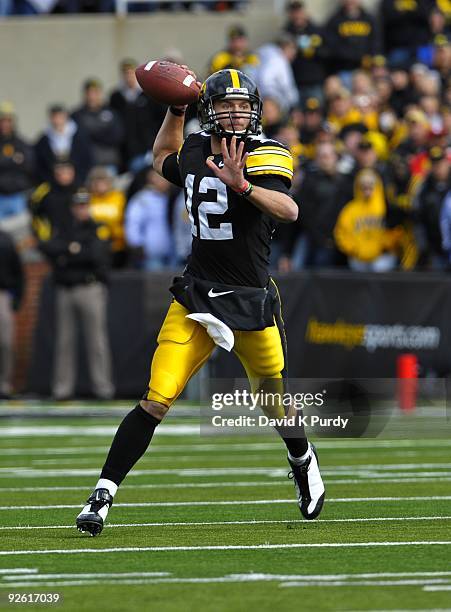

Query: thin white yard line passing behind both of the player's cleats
left=0, top=495, right=451, bottom=511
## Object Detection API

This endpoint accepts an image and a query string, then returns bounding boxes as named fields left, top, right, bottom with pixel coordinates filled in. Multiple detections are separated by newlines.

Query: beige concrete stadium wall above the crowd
left=0, top=0, right=377, bottom=138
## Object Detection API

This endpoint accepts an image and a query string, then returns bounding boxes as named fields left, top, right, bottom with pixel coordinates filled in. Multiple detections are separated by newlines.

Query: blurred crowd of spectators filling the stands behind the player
left=0, top=0, right=451, bottom=395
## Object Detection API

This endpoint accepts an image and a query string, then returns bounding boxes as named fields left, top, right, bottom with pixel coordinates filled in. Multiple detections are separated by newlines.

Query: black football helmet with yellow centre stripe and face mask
left=197, top=69, right=263, bottom=138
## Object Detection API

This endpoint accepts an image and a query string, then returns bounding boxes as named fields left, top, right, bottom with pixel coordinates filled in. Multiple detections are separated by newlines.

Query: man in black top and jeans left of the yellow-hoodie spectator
left=279, top=143, right=346, bottom=271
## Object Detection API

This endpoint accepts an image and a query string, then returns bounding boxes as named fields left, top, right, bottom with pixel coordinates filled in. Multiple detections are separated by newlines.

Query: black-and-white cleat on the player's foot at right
left=288, top=442, right=326, bottom=521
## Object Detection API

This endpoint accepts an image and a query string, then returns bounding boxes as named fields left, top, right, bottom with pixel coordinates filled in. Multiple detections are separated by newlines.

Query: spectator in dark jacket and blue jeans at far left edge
left=0, top=102, right=34, bottom=220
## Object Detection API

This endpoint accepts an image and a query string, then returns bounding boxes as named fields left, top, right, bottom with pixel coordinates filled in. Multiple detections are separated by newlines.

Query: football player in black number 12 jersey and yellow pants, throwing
left=76, top=69, right=325, bottom=535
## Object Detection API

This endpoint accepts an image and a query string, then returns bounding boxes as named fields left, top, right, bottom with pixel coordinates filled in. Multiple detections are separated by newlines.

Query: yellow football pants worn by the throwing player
left=145, top=300, right=285, bottom=407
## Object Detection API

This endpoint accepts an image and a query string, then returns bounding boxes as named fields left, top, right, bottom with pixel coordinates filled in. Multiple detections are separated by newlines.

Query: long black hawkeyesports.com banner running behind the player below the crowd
left=29, top=271, right=451, bottom=397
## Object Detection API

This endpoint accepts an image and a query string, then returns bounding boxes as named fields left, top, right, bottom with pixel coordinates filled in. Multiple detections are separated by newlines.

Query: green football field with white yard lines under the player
left=0, top=404, right=451, bottom=612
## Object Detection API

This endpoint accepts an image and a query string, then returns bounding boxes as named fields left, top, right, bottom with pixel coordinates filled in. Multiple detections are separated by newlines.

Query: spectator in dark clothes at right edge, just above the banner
left=414, top=147, right=451, bottom=270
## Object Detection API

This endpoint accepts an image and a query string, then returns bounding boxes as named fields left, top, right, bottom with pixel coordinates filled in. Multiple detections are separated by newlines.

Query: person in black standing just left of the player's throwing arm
left=110, top=59, right=166, bottom=173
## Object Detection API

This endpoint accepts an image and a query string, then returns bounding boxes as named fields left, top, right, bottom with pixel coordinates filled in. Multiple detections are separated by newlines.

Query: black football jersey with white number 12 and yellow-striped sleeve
left=163, top=132, right=293, bottom=287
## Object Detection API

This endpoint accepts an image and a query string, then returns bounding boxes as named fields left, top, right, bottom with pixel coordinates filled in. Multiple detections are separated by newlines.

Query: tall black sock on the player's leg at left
left=100, top=405, right=161, bottom=486
